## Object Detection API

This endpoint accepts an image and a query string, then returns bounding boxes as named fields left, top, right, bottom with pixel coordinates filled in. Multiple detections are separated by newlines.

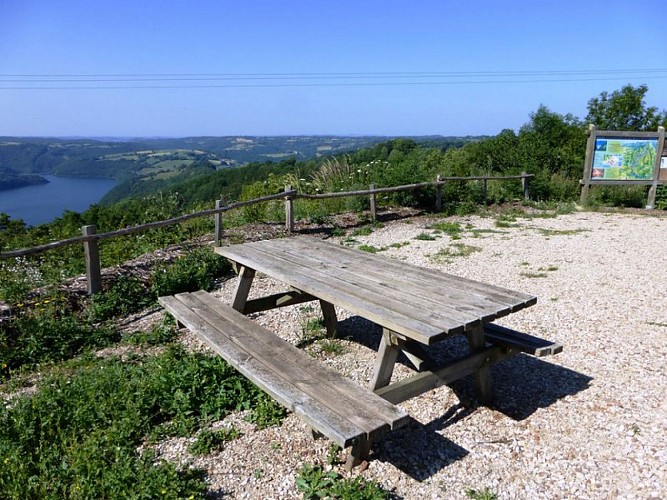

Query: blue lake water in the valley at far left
left=0, top=175, right=118, bottom=226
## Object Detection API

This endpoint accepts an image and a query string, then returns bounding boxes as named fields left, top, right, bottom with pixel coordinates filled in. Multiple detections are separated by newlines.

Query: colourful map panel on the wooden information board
left=591, top=137, right=658, bottom=181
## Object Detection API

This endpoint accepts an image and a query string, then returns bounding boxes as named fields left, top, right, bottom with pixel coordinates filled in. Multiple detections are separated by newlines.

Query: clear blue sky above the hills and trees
left=0, top=0, right=667, bottom=137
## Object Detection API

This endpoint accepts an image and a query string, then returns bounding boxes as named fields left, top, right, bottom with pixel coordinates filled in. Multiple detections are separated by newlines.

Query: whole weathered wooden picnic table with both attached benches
left=159, top=236, right=562, bottom=470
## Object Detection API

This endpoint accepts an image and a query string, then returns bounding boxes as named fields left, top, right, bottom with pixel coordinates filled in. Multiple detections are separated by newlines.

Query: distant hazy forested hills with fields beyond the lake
left=0, top=136, right=474, bottom=201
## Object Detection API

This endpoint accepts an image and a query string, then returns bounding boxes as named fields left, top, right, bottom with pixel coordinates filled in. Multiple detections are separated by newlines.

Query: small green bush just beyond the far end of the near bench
left=152, top=248, right=231, bottom=297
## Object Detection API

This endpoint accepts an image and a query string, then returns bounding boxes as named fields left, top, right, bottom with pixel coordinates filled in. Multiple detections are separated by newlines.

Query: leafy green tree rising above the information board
left=586, top=85, right=667, bottom=131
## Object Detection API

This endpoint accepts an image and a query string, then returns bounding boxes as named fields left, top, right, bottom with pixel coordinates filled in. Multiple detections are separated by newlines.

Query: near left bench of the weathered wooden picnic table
left=158, top=291, right=409, bottom=470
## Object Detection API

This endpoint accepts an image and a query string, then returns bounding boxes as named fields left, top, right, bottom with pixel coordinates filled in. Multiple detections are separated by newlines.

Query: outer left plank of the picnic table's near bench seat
left=158, top=297, right=365, bottom=447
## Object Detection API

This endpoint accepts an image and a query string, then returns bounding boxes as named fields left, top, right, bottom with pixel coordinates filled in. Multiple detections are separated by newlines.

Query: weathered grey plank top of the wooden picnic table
left=215, top=236, right=537, bottom=344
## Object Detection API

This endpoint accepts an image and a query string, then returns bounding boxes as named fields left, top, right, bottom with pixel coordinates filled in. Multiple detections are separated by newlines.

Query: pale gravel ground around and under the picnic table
left=153, top=212, right=667, bottom=499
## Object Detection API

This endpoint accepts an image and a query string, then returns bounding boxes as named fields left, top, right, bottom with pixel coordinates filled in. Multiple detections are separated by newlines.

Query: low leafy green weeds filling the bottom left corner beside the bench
left=0, top=346, right=276, bottom=499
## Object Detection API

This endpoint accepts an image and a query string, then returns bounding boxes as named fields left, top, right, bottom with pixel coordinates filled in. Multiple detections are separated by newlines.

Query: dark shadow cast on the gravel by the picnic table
left=339, top=316, right=593, bottom=481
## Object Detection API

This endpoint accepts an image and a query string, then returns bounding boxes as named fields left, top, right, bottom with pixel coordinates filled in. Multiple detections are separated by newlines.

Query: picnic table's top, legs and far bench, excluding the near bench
left=215, top=236, right=548, bottom=404
